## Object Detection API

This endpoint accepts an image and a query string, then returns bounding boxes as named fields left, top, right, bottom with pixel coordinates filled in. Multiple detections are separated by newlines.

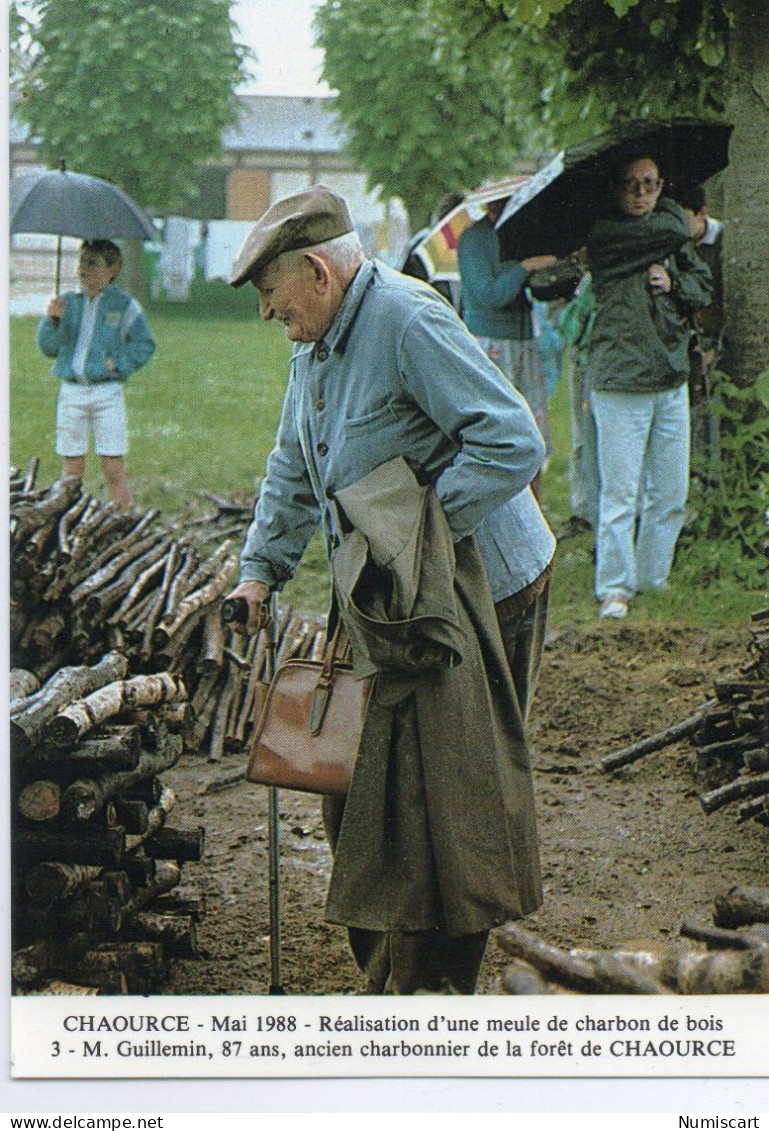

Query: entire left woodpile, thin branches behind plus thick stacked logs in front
left=10, top=460, right=325, bottom=994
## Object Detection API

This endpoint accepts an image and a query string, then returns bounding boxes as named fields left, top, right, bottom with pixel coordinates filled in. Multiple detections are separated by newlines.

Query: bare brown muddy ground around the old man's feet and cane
left=159, top=622, right=769, bottom=994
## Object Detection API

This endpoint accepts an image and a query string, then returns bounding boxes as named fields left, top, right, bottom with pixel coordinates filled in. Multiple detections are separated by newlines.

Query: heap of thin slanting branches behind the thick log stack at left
left=10, top=470, right=237, bottom=677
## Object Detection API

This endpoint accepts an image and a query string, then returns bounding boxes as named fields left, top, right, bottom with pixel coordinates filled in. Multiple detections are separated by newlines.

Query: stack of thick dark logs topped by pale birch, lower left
left=11, top=653, right=204, bottom=993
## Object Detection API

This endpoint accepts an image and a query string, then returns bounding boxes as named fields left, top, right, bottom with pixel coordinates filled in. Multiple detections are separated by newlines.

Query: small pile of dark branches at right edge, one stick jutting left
left=600, top=610, right=769, bottom=827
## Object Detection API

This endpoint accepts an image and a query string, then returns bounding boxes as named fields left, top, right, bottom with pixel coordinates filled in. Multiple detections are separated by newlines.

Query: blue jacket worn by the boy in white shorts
left=37, top=283, right=155, bottom=383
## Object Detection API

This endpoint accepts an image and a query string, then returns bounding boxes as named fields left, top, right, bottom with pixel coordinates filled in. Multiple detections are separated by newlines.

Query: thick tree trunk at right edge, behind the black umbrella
left=724, top=0, right=769, bottom=387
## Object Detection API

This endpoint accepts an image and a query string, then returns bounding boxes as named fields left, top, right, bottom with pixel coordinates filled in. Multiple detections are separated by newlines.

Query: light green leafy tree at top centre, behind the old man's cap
left=316, top=0, right=558, bottom=226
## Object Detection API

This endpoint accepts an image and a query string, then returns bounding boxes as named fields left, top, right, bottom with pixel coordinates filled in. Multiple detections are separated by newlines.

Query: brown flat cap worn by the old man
left=230, top=184, right=354, bottom=286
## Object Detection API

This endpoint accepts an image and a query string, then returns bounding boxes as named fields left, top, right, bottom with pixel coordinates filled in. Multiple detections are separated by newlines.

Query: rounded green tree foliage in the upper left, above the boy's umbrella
left=11, top=0, right=247, bottom=211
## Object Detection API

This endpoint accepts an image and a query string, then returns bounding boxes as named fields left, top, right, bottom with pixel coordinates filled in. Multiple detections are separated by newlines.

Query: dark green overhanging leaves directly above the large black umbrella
left=432, top=0, right=729, bottom=139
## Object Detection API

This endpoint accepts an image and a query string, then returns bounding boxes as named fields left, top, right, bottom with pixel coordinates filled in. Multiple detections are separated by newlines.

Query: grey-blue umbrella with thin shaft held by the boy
left=10, top=161, right=157, bottom=294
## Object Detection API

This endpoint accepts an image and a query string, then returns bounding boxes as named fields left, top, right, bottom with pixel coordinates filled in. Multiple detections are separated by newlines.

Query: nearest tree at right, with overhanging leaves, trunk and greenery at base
left=432, top=0, right=769, bottom=586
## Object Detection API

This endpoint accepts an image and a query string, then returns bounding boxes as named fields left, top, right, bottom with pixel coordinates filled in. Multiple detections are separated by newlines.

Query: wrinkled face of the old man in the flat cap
left=254, top=257, right=335, bottom=342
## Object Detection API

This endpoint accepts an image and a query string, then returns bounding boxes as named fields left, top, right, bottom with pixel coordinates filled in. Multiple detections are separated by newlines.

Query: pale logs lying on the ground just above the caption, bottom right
left=500, top=888, right=769, bottom=994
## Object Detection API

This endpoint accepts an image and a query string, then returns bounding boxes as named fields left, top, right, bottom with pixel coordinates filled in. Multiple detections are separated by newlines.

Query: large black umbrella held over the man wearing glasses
left=496, top=119, right=732, bottom=259
